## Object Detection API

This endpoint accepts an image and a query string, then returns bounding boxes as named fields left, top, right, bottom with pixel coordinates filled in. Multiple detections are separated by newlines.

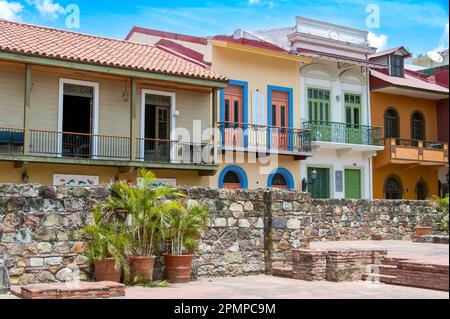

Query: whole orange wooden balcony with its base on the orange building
left=376, top=138, right=448, bottom=167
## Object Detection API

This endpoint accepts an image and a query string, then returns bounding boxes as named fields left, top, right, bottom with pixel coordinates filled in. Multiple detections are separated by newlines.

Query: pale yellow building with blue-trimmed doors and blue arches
left=127, top=28, right=312, bottom=189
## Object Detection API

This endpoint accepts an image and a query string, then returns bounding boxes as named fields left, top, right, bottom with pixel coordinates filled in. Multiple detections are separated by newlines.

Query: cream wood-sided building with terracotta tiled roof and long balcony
left=0, top=20, right=227, bottom=185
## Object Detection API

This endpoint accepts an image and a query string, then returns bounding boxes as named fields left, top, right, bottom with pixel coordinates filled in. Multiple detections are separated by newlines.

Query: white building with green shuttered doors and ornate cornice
left=251, top=17, right=386, bottom=199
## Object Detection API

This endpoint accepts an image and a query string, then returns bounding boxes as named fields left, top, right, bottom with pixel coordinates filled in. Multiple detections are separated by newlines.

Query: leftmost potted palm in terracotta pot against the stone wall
left=84, top=206, right=131, bottom=282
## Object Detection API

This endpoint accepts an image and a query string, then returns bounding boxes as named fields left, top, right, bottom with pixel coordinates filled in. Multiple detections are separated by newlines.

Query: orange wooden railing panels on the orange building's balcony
left=386, top=138, right=448, bottom=164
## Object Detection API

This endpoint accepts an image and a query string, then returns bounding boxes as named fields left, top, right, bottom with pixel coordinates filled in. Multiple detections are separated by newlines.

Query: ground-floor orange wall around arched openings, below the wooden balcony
left=373, top=164, right=438, bottom=199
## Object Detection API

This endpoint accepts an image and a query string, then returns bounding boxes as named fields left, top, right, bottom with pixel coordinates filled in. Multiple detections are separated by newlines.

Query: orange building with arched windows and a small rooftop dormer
left=370, top=47, right=449, bottom=199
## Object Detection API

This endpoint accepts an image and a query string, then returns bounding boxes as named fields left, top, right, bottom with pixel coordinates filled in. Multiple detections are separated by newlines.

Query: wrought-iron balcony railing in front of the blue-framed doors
left=218, top=122, right=311, bottom=154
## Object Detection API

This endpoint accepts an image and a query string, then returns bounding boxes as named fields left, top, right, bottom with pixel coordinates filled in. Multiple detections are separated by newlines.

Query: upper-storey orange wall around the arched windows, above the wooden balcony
left=370, top=92, right=437, bottom=142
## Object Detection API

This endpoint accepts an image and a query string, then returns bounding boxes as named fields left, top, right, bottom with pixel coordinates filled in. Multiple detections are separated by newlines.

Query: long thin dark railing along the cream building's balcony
left=0, top=128, right=214, bottom=164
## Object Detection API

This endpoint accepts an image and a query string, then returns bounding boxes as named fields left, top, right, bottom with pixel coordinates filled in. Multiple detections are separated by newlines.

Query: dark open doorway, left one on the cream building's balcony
left=60, top=83, right=95, bottom=158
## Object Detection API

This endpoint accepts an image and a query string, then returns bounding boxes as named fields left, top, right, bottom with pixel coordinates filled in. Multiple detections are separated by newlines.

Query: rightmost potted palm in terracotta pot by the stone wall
left=164, top=205, right=208, bottom=283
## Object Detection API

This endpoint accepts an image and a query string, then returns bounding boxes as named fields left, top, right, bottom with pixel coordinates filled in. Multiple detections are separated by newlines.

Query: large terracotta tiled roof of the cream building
left=0, top=20, right=226, bottom=81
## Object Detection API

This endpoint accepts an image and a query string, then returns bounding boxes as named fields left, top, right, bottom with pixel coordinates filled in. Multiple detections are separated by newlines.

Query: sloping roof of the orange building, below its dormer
left=370, top=70, right=449, bottom=94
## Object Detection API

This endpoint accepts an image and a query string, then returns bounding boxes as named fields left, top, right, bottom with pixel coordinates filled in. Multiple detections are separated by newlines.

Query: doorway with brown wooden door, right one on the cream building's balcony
left=142, top=93, right=173, bottom=162
